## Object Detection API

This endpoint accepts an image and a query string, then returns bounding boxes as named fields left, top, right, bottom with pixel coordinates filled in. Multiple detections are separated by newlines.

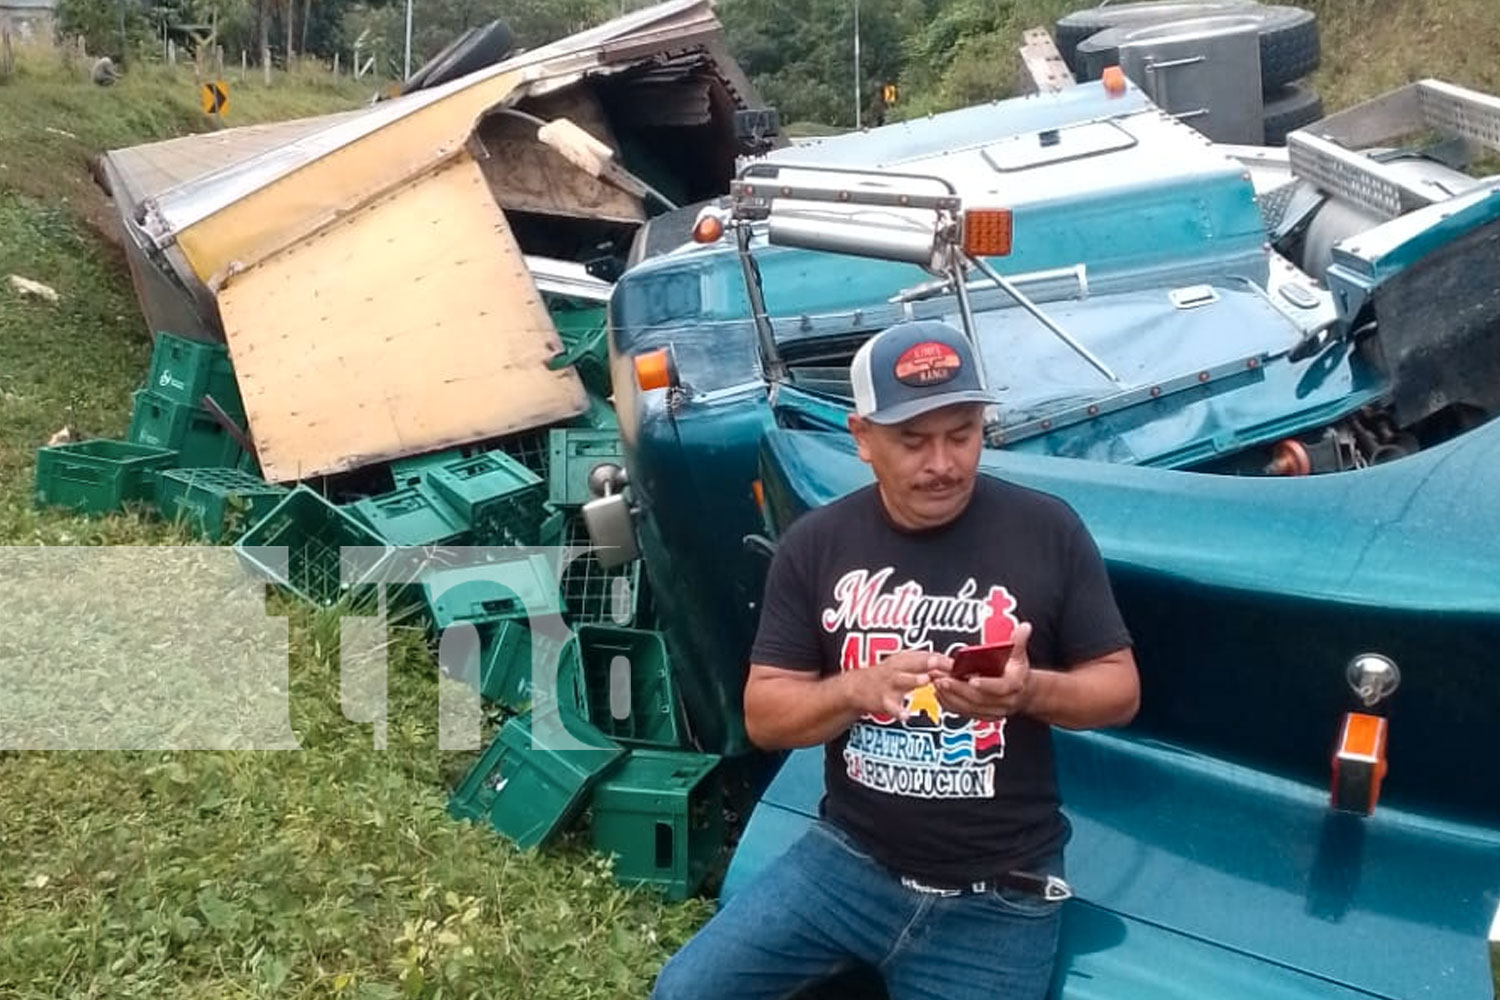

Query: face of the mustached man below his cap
left=849, top=403, right=984, bottom=528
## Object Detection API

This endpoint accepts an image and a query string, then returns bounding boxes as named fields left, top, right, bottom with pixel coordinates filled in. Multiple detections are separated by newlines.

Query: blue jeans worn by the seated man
left=651, top=822, right=1062, bottom=1000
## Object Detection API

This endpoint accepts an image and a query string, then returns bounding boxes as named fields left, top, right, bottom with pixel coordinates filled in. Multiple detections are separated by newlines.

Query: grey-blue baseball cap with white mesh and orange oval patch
left=849, top=319, right=996, bottom=424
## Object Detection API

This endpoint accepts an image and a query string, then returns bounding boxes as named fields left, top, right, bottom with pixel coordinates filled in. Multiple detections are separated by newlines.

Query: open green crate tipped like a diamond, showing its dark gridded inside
left=234, top=486, right=393, bottom=606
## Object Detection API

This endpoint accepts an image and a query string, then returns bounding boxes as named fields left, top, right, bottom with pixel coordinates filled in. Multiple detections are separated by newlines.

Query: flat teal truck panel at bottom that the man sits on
left=735, top=730, right=1500, bottom=1000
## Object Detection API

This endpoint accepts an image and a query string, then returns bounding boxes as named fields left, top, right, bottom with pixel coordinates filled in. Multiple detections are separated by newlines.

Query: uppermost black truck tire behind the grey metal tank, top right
left=1074, top=4, right=1322, bottom=91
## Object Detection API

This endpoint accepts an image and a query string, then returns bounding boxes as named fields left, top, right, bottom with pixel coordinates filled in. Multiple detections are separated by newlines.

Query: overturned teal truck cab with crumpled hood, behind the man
left=596, top=74, right=1500, bottom=1000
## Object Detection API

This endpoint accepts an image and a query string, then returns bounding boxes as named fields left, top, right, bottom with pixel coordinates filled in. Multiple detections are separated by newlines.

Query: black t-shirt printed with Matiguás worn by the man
left=752, top=475, right=1130, bottom=885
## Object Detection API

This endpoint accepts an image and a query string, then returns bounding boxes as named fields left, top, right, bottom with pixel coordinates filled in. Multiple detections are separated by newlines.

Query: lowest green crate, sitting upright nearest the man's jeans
left=590, top=750, right=725, bottom=900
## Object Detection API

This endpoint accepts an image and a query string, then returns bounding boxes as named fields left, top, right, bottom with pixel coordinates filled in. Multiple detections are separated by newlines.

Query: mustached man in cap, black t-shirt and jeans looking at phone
left=654, top=321, right=1140, bottom=1000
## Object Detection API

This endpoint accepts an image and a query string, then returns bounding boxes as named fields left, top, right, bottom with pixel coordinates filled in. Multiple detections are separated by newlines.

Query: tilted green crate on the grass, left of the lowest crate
left=449, top=712, right=626, bottom=850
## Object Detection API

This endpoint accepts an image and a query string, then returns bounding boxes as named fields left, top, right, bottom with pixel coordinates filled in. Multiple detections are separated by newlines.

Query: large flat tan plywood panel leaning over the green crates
left=219, top=153, right=587, bottom=481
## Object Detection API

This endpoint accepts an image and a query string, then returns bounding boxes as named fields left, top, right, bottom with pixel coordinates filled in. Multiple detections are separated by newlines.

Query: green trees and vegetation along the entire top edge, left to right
left=35, top=0, right=1500, bottom=127
